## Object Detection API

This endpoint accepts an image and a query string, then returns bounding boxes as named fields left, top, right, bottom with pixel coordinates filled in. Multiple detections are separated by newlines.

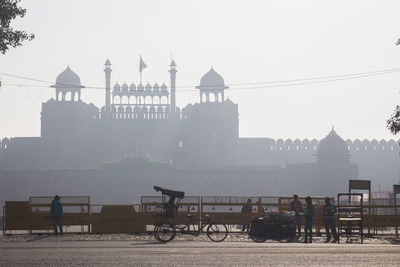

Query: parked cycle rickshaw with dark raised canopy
left=153, top=186, right=228, bottom=243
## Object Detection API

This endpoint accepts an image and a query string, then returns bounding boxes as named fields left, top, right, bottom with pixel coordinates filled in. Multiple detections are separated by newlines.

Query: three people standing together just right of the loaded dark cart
left=290, top=195, right=338, bottom=243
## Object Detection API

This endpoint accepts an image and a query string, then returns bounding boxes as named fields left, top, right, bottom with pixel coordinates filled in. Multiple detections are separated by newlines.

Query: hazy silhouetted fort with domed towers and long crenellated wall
left=0, top=59, right=400, bottom=195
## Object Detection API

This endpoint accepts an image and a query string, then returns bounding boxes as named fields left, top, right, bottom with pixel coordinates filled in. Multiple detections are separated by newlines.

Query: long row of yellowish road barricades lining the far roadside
left=3, top=196, right=400, bottom=234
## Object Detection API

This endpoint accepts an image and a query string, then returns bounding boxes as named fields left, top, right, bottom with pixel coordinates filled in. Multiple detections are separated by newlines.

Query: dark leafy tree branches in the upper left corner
left=0, top=0, right=35, bottom=54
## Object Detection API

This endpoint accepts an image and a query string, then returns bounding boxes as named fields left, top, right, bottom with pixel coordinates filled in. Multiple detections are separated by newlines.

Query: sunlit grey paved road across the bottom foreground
left=0, top=241, right=400, bottom=266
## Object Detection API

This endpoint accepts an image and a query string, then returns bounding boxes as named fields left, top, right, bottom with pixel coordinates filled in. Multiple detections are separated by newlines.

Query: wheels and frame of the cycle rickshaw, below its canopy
left=154, top=214, right=228, bottom=243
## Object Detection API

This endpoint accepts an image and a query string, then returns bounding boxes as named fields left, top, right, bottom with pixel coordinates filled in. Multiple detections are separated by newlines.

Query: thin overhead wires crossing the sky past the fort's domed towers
left=0, top=68, right=400, bottom=92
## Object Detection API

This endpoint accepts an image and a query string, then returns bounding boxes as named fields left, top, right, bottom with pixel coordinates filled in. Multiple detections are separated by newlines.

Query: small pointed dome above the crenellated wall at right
left=317, top=128, right=349, bottom=155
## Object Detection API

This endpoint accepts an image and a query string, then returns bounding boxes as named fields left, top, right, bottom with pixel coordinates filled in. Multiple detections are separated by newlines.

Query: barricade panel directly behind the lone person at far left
left=29, top=196, right=90, bottom=233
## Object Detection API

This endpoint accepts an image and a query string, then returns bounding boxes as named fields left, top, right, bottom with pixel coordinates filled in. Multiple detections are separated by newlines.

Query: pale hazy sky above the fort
left=0, top=0, right=400, bottom=139
